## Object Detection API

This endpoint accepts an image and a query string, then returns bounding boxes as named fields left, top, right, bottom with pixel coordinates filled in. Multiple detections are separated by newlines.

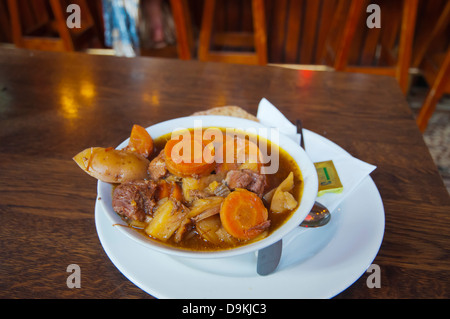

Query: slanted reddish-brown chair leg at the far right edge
left=416, top=49, right=450, bottom=133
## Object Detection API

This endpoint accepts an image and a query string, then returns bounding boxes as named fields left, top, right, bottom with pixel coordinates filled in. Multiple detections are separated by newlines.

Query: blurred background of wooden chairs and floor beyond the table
left=0, top=0, right=450, bottom=192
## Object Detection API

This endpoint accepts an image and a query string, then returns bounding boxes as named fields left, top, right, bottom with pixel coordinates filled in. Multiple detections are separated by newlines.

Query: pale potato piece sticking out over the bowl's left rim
left=73, top=147, right=150, bottom=183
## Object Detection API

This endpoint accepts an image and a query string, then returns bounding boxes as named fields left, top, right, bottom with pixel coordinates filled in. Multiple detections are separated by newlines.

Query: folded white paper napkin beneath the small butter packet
left=257, top=98, right=376, bottom=212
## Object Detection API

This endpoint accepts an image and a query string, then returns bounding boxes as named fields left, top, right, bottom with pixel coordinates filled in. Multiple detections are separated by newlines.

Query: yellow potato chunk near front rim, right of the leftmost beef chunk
left=145, top=198, right=189, bottom=241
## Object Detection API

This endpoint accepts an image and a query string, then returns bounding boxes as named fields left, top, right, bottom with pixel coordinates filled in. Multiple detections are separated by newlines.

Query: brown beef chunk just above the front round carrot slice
left=225, top=169, right=266, bottom=197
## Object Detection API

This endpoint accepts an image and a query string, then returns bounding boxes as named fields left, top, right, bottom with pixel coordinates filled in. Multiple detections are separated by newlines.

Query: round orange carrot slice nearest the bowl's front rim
left=220, top=189, right=270, bottom=240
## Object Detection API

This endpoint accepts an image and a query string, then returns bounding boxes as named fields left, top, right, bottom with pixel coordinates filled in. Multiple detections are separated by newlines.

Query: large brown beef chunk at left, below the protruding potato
left=112, top=180, right=156, bottom=221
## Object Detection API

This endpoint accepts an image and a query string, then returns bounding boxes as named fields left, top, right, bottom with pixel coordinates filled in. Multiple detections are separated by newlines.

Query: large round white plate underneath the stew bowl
left=95, top=130, right=384, bottom=299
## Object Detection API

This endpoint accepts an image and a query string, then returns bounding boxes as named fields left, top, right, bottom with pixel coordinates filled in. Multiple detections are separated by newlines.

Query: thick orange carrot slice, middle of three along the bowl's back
left=164, top=132, right=215, bottom=177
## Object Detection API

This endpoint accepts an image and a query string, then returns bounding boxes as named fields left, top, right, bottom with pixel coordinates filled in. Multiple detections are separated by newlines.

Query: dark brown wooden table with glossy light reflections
left=0, top=49, right=450, bottom=298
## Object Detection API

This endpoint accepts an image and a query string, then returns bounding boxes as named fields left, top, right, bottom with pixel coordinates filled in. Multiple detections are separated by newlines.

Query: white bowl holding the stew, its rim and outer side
left=97, top=115, right=318, bottom=258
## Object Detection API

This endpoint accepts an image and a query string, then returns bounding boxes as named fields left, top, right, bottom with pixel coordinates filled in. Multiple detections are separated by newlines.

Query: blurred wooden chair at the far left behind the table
left=8, top=0, right=97, bottom=51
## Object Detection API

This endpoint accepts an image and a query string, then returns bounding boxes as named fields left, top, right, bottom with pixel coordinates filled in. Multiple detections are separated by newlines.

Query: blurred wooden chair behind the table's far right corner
left=325, top=0, right=418, bottom=94
